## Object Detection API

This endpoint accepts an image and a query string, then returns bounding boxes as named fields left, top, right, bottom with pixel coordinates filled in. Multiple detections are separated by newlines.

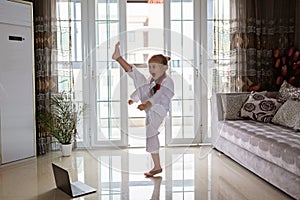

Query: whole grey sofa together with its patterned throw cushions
left=212, top=89, right=300, bottom=199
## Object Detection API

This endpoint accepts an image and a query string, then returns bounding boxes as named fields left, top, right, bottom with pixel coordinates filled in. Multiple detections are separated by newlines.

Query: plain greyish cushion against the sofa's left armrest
left=221, top=93, right=249, bottom=120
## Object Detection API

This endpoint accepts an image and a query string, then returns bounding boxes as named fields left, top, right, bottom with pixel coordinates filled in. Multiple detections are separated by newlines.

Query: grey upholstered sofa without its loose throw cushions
left=213, top=93, right=300, bottom=199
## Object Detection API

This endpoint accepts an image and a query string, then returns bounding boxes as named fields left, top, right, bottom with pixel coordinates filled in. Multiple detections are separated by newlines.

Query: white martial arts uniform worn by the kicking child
left=127, top=65, right=174, bottom=153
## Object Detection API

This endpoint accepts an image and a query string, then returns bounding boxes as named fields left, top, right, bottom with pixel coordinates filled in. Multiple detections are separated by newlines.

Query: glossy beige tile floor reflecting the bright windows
left=0, top=146, right=290, bottom=200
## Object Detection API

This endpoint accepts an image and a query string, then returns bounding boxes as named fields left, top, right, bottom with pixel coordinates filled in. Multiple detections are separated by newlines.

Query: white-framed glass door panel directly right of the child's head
left=165, top=0, right=202, bottom=145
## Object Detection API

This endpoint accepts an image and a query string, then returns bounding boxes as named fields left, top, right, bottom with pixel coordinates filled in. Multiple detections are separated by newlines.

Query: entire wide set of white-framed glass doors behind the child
left=57, top=0, right=203, bottom=148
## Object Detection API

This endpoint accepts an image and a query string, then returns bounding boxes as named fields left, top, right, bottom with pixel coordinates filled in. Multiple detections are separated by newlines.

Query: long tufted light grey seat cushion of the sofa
left=218, top=120, right=300, bottom=176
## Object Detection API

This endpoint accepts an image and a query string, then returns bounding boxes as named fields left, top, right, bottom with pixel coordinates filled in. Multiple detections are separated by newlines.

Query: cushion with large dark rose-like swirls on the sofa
left=241, top=92, right=282, bottom=122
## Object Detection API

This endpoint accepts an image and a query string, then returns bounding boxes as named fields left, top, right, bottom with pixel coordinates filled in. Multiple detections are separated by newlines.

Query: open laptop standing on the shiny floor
left=52, top=163, right=96, bottom=198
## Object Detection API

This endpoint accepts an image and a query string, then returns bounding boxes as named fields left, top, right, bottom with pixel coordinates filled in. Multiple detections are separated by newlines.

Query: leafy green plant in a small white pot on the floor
left=39, top=91, right=84, bottom=156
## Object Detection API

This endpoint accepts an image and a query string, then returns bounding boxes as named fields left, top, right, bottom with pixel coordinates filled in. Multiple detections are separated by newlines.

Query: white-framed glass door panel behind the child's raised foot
left=89, top=0, right=127, bottom=147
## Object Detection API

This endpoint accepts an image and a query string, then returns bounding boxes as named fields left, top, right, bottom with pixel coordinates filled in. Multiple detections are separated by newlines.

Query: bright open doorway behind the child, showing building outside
left=126, top=2, right=165, bottom=147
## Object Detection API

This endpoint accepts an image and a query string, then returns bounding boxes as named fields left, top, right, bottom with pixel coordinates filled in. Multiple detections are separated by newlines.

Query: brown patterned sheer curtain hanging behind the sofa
left=214, top=0, right=295, bottom=92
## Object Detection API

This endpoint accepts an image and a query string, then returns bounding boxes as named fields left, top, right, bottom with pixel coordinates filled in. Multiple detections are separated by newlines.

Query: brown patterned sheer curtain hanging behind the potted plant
left=34, top=0, right=73, bottom=154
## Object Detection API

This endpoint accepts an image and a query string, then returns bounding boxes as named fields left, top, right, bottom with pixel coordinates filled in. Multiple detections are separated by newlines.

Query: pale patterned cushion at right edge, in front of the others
left=272, top=100, right=300, bottom=130
